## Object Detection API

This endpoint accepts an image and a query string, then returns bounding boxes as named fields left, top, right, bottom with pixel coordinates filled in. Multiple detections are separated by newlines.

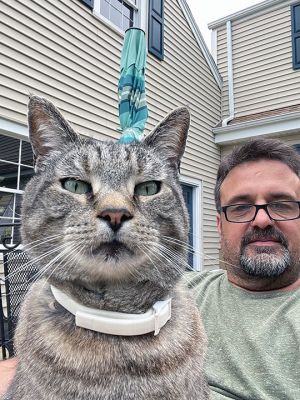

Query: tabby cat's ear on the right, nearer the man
left=144, top=107, right=190, bottom=165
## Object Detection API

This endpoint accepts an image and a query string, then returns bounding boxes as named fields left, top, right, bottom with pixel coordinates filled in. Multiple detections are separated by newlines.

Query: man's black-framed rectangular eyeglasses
left=220, top=201, right=300, bottom=224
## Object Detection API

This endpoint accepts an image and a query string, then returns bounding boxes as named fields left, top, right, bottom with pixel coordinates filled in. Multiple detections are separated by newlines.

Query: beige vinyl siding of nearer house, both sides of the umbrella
left=0, top=0, right=220, bottom=267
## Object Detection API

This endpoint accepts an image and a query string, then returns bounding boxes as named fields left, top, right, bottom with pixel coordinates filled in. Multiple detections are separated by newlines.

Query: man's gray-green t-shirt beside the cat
left=188, top=270, right=300, bottom=400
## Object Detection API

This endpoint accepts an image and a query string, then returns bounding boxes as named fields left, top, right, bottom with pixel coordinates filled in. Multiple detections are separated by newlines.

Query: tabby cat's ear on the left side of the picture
left=28, top=95, right=79, bottom=159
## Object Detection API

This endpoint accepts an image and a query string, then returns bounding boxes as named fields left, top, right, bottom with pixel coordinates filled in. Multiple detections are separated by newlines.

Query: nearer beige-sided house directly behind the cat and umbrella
left=0, top=0, right=222, bottom=270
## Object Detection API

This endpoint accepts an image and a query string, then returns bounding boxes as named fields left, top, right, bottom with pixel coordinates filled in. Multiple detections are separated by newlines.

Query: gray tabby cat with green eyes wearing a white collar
left=4, top=96, right=208, bottom=400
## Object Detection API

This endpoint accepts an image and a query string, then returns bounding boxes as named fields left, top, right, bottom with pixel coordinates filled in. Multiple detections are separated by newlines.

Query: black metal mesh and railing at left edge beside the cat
left=0, top=223, right=37, bottom=359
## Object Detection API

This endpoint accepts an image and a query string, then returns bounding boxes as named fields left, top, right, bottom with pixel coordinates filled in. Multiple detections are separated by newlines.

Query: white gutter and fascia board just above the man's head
left=213, top=112, right=300, bottom=145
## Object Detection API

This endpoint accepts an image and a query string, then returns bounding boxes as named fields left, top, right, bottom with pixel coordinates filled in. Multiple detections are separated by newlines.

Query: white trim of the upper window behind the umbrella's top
left=93, top=0, right=148, bottom=36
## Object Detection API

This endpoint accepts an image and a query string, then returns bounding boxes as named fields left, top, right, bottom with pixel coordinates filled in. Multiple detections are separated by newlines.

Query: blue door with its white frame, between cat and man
left=180, top=176, right=202, bottom=271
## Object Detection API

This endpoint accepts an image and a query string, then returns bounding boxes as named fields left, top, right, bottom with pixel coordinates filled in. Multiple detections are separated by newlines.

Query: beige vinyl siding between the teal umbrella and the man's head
left=146, top=1, right=220, bottom=268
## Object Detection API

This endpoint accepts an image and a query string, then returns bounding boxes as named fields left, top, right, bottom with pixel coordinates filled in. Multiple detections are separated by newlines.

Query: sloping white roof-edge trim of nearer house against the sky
left=178, top=0, right=222, bottom=88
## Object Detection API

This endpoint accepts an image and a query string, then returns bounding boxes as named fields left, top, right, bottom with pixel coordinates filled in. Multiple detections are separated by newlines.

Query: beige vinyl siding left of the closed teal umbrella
left=0, top=0, right=122, bottom=138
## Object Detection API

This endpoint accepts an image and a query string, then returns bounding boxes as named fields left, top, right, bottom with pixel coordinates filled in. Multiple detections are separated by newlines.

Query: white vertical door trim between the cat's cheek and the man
left=180, top=175, right=203, bottom=271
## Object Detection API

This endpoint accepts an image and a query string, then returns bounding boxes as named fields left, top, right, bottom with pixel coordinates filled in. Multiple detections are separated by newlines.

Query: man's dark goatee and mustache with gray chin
left=240, top=227, right=292, bottom=278
